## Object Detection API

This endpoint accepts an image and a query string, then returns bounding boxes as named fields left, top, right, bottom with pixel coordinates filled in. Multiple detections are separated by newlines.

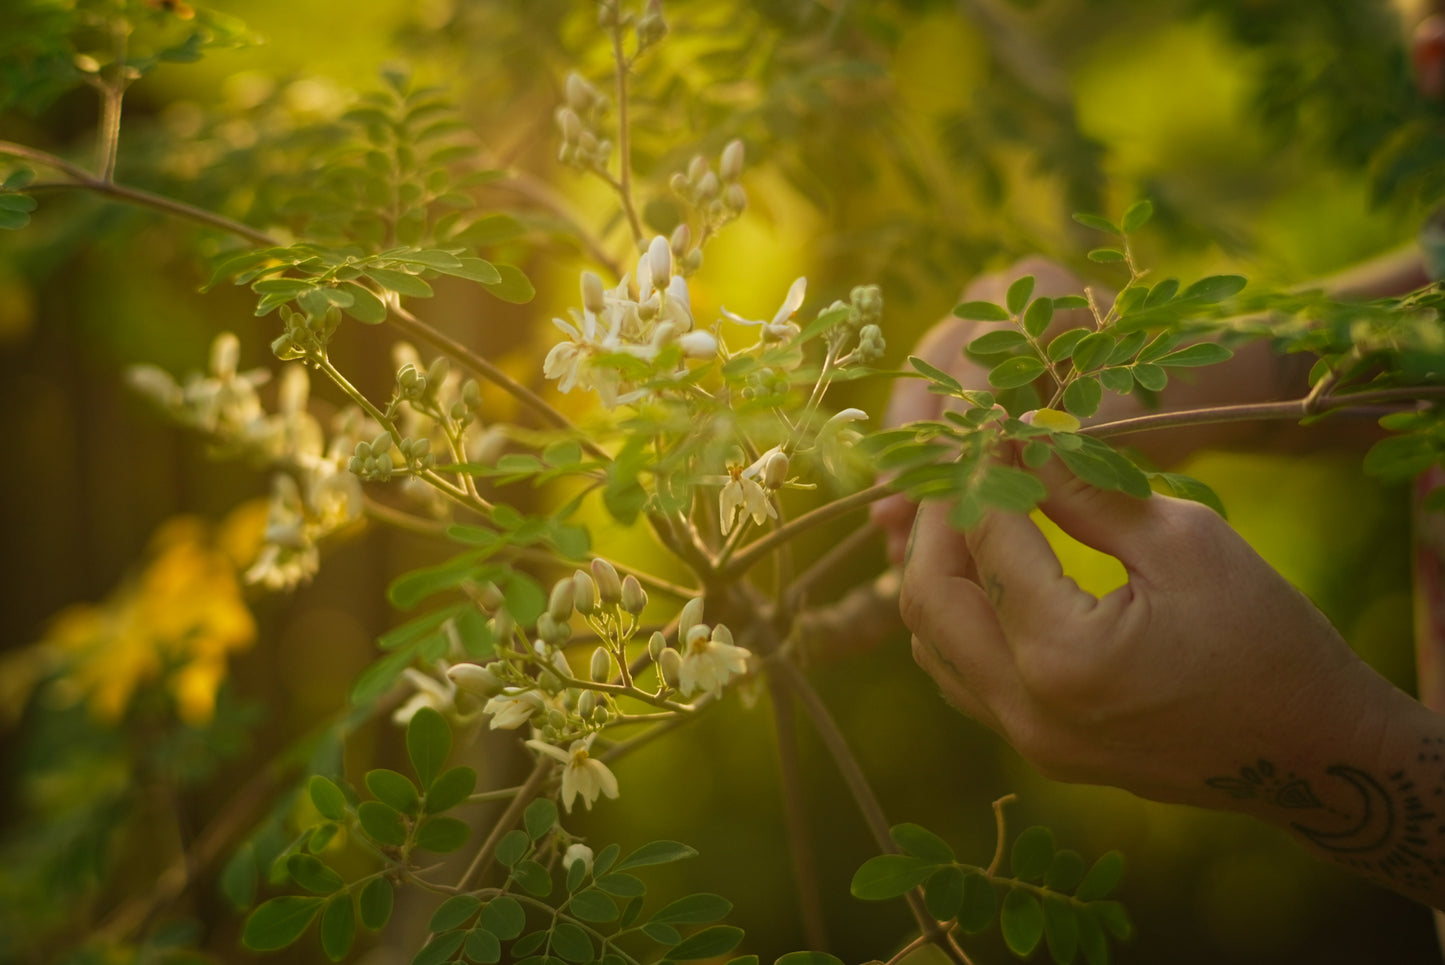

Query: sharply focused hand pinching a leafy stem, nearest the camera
left=900, top=459, right=1418, bottom=808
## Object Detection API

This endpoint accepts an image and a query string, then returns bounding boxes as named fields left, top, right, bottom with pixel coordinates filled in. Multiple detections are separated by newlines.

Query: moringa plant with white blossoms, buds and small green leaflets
left=0, top=0, right=1445, bottom=965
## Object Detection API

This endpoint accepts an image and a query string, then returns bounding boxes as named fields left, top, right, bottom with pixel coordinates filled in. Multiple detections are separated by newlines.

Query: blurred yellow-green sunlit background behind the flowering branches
left=0, top=0, right=1441, bottom=965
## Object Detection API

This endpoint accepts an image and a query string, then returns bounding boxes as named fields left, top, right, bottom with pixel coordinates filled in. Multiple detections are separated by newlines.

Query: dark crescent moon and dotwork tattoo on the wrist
left=1205, top=738, right=1445, bottom=891
